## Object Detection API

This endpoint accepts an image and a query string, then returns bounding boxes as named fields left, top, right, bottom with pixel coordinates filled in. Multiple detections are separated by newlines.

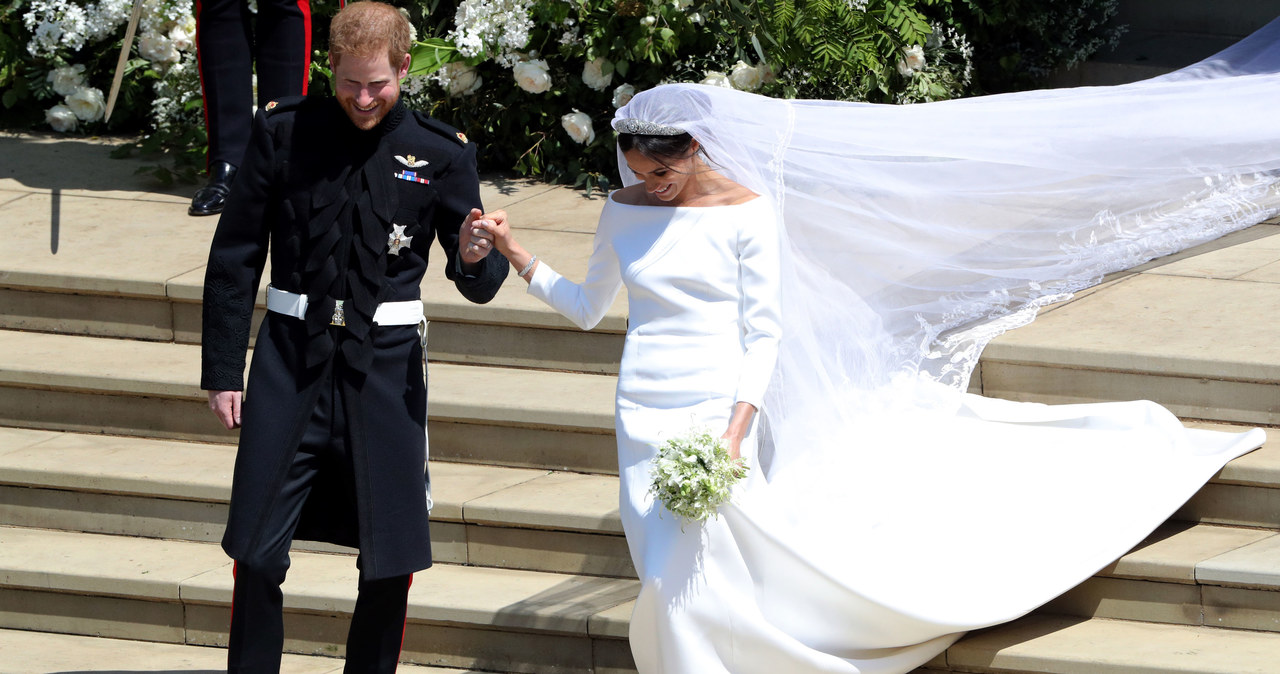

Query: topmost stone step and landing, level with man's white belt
left=0, top=161, right=626, bottom=373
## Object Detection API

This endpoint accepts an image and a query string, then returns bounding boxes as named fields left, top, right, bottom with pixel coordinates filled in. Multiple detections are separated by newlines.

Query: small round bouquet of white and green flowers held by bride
left=649, top=428, right=748, bottom=522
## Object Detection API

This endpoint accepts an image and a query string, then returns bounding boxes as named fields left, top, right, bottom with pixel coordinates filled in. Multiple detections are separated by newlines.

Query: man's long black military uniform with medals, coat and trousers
left=201, top=97, right=508, bottom=671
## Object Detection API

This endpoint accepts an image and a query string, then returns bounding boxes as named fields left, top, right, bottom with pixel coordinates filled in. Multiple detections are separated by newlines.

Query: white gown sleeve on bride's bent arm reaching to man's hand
left=519, top=217, right=622, bottom=330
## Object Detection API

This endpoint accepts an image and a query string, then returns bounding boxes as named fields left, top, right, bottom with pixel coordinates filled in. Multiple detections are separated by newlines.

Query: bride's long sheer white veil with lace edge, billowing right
left=617, top=19, right=1280, bottom=478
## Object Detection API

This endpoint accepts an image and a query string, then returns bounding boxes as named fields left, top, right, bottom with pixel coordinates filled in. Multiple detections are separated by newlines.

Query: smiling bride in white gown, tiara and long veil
left=476, top=22, right=1280, bottom=674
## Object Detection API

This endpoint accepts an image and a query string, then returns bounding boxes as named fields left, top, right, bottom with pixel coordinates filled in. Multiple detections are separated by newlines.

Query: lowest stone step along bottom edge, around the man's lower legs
left=0, top=629, right=480, bottom=674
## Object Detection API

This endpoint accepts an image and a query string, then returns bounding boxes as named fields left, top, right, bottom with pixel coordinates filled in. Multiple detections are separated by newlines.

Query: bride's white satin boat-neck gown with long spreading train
left=530, top=191, right=1262, bottom=674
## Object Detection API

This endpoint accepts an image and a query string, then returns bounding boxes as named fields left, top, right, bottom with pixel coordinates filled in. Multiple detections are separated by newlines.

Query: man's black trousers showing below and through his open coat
left=227, top=376, right=413, bottom=673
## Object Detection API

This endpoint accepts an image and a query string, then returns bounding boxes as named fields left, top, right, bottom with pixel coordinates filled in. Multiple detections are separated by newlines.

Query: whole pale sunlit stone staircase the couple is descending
left=0, top=129, right=1280, bottom=674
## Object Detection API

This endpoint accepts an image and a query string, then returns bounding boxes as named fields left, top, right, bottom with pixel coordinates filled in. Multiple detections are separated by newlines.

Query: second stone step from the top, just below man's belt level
left=0, top=330, right=617, bottom=473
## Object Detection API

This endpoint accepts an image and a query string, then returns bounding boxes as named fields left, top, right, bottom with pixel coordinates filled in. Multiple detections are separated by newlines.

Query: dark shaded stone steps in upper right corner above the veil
left=1053, top=0, right=1280, bottom=87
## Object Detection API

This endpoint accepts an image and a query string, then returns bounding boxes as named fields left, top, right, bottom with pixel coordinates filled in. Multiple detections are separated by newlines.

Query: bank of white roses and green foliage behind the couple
left=0, top=0, right=1117, bottom=189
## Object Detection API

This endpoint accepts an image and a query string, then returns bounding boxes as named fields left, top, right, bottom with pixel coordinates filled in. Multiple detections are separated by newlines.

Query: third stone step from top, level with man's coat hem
left=0, top=428, right=635, bottom=578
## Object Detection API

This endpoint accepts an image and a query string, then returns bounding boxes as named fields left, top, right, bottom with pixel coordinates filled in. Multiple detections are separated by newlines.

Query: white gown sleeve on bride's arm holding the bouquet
left=736, top=206, right=782, bottom=409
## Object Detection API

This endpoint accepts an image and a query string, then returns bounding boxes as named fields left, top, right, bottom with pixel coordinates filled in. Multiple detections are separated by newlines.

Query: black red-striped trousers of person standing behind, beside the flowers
left=196, top=0, right=311, bottom=166
